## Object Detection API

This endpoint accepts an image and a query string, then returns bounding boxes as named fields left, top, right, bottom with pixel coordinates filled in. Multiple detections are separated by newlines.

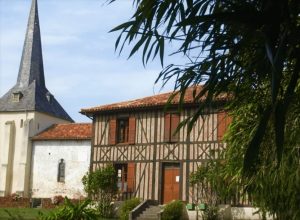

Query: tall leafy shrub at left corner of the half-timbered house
left=82, top=165, right=118, bottom=218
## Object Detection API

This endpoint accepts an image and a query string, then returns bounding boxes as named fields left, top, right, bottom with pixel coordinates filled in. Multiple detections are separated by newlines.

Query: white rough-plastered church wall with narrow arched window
left=31, top=140, right=91, bottom=199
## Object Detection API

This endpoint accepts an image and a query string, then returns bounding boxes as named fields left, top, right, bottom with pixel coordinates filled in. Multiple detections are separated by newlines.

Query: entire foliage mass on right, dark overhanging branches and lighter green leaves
left=111, top=0, right=300, bottom=219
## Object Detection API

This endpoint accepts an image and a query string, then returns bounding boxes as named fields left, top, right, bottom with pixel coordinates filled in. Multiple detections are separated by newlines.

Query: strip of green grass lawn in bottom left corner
left=0, top=208, right=51, bottom=220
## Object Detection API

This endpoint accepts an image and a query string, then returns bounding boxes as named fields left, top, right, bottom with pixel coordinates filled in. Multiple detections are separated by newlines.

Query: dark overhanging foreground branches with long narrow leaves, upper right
left=110, top=0, right=300, bottom=174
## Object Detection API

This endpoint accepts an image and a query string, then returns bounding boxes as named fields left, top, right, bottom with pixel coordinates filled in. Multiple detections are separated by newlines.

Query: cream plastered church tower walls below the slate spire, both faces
left=0, top=111, right=68, bottom=197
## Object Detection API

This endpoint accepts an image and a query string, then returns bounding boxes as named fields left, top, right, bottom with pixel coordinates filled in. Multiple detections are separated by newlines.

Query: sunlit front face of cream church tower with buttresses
left=0, top=112, right=34, bottom=196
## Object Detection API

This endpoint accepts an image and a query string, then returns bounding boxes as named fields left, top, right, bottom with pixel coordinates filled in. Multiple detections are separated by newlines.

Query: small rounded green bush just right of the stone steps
left=162, top=200, right=184, bottom=220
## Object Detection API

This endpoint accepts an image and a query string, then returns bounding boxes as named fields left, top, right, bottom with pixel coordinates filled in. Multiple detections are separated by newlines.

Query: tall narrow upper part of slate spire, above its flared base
left=17, top=0, right=45, bottom=88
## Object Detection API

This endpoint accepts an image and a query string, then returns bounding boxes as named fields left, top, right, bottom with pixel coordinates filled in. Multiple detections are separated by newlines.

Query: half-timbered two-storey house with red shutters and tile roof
left=81, top=87, right=229, bottom=204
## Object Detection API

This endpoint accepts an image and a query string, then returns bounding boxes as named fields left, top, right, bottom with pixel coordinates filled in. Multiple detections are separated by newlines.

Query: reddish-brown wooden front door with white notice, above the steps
left=162, top=164, right=180, bottom=204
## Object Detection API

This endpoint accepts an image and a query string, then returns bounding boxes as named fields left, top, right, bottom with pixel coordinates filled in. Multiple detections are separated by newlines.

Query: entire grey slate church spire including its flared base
left=0, top=0, right=73, bottom=121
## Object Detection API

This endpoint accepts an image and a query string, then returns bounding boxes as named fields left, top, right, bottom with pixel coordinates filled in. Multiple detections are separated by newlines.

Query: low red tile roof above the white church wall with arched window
left=32, top=123, right=92, bottom=140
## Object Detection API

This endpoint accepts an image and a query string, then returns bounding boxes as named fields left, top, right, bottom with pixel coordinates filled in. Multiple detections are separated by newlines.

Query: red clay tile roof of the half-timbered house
left=80, top=86, right=225, bottom=114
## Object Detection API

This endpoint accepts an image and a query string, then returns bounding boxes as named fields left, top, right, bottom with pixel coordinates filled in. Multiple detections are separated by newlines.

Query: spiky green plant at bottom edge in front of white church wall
left=40, top=197, right=98, bottom=220
